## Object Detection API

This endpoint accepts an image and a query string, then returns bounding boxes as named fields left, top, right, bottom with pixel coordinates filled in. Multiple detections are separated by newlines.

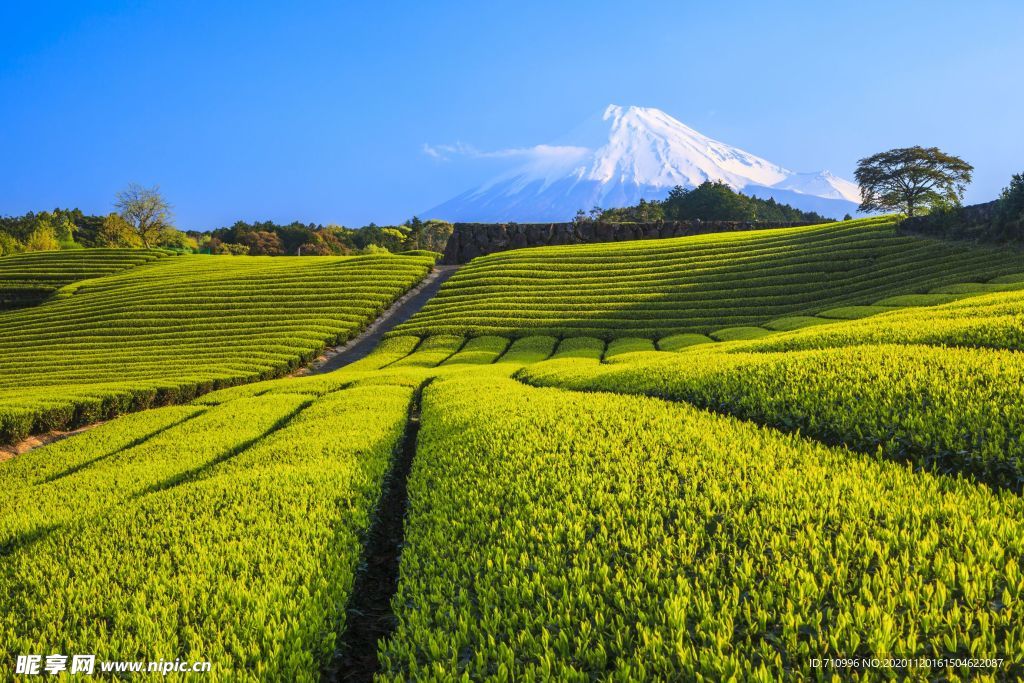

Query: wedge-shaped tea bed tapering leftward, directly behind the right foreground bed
left=519, top=345, right=1024, bottom=492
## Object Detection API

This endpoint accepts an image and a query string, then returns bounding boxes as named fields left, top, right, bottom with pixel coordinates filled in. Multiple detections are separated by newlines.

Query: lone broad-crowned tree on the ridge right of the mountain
left=854, top=146, right=974, bottom=216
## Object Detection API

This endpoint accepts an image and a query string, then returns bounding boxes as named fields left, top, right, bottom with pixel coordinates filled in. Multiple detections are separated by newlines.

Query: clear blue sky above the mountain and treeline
left=0, top=0, right=1024, bottom=229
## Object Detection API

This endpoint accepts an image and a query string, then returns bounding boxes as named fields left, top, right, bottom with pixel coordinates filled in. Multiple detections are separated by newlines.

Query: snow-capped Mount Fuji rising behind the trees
left=425, top=104, right=860, bottom=222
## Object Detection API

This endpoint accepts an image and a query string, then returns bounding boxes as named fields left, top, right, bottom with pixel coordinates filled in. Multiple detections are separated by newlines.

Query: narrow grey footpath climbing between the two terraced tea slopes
left=293, top=265, right=459, bottom=377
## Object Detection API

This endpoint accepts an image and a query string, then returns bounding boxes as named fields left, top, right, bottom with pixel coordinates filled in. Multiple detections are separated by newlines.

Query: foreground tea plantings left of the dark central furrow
left=0, top=385, right=414, bottom=681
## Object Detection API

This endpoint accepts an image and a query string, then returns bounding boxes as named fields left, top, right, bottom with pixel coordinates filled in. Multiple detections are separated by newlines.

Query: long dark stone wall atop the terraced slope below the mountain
left=441, top=220, right=823, bottom=265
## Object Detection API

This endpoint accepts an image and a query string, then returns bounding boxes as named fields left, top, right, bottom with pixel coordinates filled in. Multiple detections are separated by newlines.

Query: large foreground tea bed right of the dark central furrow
left=380, top=376, right=1024, bottom=681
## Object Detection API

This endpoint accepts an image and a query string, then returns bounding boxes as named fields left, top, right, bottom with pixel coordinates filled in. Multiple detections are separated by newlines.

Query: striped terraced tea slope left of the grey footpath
left=0, top=250, right=433, bottom=442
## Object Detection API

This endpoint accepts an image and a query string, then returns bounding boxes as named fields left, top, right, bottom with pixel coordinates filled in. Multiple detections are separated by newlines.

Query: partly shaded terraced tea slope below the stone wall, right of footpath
left=394, top=217, right=1024, bottom=339
